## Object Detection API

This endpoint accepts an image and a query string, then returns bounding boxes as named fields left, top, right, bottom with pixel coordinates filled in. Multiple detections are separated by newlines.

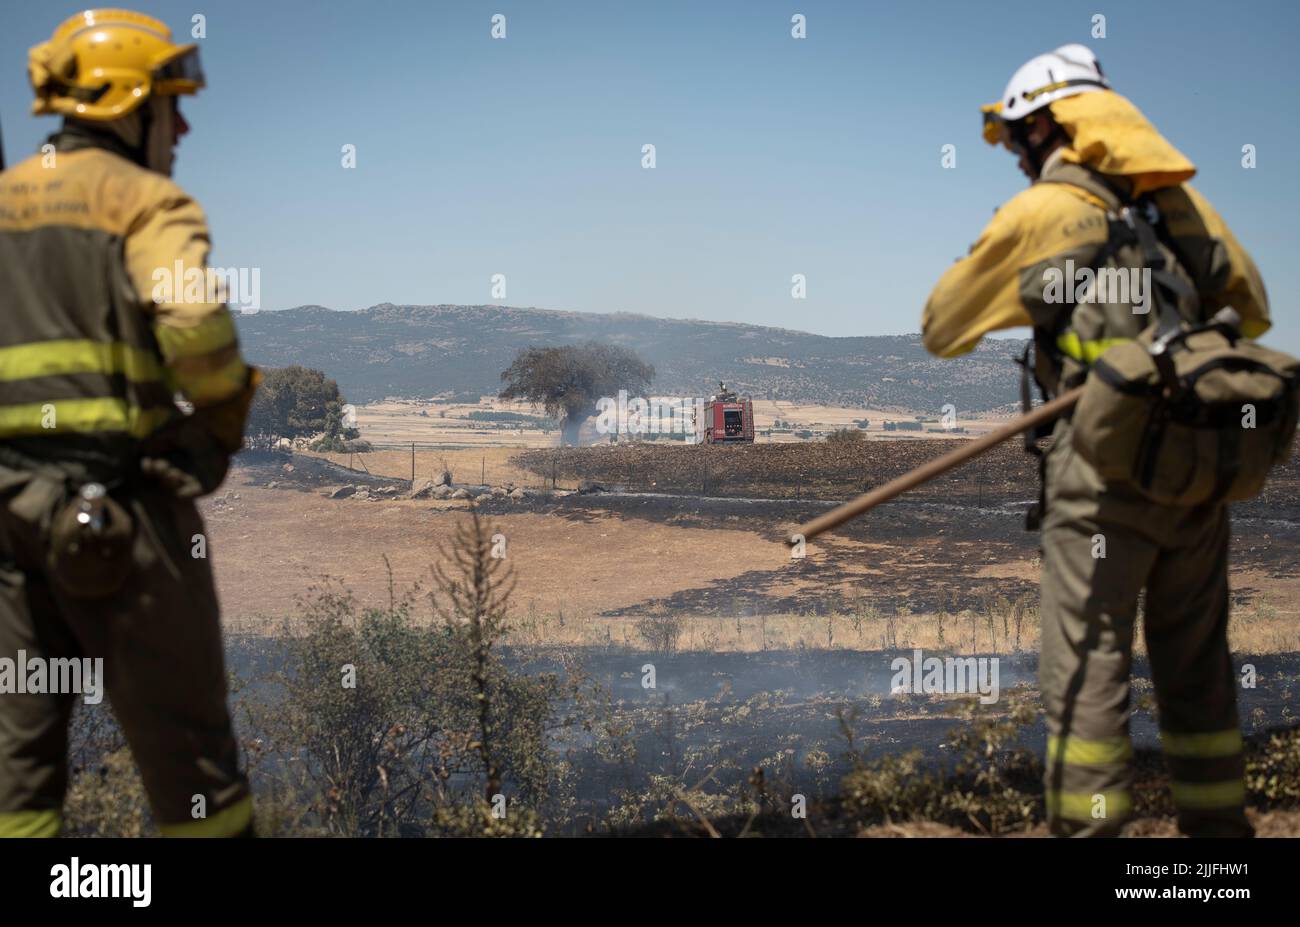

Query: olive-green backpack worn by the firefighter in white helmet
left=1071, top=197, right=1300, bottom=506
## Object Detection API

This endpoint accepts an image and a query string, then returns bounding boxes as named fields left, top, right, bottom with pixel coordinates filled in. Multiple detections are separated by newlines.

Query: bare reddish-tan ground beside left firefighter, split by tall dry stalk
left=204, top=472, right=788, bottom=631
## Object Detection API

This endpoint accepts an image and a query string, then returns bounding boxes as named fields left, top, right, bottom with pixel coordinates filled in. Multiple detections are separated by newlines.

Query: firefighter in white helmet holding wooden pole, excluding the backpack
left=922, top=46, right=1269, bottom=836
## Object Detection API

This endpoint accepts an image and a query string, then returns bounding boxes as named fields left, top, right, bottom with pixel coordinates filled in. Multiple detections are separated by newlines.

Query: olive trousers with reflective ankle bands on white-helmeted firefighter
left=1039, top=421, right=1252, bottom=836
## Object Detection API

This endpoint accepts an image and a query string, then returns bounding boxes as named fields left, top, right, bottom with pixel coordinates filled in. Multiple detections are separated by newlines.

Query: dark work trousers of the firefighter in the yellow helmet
left=0, top=471, right=252, bottom=836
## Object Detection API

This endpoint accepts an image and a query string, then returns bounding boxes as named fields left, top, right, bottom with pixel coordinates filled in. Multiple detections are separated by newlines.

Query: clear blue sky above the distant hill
left=0, top=0, right=1300, bottom=351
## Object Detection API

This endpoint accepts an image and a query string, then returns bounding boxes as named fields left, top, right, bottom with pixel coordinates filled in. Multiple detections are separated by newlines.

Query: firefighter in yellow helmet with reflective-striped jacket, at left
left=0, top=9, right=257, bottom=836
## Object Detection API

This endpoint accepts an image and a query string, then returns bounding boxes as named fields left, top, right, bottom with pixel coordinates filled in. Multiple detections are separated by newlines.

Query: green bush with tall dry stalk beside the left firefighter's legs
left=255, top=514, right=563, bottom=836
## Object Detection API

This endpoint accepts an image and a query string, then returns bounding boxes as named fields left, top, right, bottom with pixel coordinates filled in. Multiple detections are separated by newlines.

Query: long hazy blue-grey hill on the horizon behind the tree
left=237, top=303, right=1023, bottom=413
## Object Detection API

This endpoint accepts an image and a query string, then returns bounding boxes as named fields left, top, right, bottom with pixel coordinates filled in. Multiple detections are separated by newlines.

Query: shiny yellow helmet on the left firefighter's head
left=27, top=9, right=204, bottom=122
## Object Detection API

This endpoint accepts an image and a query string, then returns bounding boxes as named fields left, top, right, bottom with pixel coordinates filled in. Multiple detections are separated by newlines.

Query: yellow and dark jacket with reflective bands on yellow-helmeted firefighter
left=0, top=126, right=255, bottom=478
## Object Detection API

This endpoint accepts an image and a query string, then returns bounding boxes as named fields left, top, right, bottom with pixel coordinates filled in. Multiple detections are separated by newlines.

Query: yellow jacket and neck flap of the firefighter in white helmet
left=922, top=91, right=1269, bottom=391
